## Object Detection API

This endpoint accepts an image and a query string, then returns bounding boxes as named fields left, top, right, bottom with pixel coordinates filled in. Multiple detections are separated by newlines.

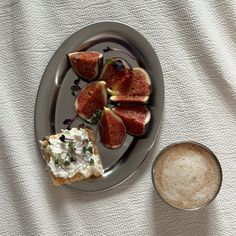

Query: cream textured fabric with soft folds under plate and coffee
left=0, top=0, right=236, bottom=236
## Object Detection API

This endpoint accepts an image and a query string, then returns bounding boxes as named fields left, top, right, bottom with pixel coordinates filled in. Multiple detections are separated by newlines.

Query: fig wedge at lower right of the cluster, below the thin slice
left=112, top=104, right=151, bottom=136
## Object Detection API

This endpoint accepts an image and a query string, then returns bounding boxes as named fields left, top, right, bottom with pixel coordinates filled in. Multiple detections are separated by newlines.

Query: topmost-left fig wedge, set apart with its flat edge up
left=68, top=51, right=103, bottom=81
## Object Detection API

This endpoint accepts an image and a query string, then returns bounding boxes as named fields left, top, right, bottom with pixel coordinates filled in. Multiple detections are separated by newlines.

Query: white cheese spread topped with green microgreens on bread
left=40, top=128, right=104, bottom=178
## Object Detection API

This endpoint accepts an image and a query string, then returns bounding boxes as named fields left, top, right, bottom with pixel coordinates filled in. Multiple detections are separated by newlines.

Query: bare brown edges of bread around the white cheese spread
left=42, top=125, right=101, bottom=186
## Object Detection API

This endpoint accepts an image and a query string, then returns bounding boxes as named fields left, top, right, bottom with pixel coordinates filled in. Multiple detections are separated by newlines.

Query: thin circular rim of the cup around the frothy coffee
left=151, top=141, right=223, bottom=211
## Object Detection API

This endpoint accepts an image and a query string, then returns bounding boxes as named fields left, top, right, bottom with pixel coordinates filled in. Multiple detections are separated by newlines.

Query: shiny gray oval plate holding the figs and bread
left=35, top=22, right=164, bottom=192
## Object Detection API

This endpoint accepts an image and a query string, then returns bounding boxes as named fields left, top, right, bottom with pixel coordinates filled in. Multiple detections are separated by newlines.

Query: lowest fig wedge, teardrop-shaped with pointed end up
left=99, top=107, right=126, bottom=149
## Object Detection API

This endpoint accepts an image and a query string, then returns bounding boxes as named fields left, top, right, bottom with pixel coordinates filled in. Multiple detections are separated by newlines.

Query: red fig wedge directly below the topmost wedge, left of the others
left=75, top=81, right=107, bottom=120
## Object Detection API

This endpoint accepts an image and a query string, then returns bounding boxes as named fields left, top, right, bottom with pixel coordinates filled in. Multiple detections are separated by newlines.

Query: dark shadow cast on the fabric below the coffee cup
left=152, top=190, right=219, bottom=236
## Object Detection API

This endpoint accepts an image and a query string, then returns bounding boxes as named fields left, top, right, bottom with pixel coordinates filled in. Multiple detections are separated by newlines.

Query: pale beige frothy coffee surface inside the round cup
left=154, top=143, right=221, bottom=209
